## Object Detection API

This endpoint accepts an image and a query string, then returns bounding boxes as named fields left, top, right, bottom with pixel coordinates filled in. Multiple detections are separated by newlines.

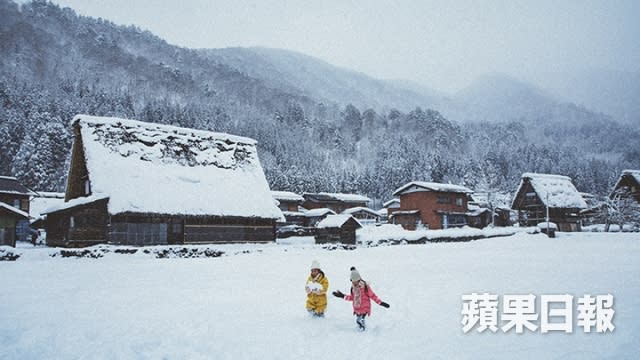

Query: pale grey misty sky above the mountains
left=35, top=0, right=640, bottom=92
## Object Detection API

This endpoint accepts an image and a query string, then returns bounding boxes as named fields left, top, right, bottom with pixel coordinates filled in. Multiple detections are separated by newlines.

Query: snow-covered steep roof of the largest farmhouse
left=73, top=115, right=282, bottom=219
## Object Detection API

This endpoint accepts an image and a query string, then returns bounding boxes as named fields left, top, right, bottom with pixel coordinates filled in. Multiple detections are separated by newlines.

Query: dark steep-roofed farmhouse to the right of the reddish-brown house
left=511, top=173, right=587, bottom=231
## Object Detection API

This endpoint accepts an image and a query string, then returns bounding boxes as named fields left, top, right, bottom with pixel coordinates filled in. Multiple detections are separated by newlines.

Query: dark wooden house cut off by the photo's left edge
left=0, top=176, right=38, bottom=246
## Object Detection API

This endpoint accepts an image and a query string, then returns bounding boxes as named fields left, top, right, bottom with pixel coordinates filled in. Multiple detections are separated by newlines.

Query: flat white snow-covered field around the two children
left=0, top=233, right=640, bottom=360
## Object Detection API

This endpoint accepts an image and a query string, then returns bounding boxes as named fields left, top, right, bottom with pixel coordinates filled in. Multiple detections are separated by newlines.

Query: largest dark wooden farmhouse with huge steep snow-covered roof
left=46, top=115, right=282, bottom=247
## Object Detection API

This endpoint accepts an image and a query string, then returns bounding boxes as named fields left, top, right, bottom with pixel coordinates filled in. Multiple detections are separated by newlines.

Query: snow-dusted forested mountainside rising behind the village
left=0, top=0, right=640, bottom=201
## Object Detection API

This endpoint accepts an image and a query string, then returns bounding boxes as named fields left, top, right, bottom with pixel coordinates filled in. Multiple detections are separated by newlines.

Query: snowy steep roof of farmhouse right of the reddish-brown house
left=514, top=173, right=587, bottom=209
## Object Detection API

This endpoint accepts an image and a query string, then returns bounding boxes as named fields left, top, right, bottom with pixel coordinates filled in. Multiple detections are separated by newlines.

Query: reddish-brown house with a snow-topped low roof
left=389, top=181, right=472, bottom=230
